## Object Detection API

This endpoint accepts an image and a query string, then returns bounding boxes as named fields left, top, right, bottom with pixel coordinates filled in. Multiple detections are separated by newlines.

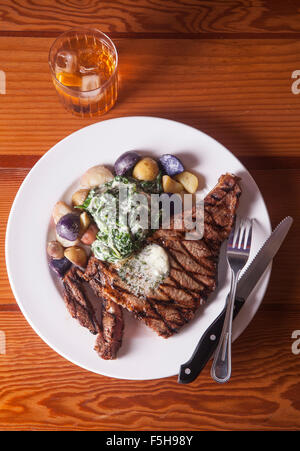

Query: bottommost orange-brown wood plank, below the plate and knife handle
left=0, top=306, right=300, bottom=431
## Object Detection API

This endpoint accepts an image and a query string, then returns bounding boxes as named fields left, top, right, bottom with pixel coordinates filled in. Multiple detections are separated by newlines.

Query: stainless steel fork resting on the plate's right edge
left=211, top=218, right=252, bottom=383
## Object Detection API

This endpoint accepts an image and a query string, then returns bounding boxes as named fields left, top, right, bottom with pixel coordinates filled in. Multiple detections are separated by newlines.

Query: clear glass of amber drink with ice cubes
left=49, top=29, right=118, bottom=117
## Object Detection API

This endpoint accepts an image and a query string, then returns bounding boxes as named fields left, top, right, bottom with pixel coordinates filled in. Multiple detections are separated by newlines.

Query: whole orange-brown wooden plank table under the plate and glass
left=0, top=0, right=300, bottom=431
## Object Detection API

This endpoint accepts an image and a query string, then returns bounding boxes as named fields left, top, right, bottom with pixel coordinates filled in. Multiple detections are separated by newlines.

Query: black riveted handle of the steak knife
left=178, top=298, right=245, bottom=384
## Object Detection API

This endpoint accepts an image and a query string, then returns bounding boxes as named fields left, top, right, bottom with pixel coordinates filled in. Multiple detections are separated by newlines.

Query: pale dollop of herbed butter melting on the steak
left=118, top=243, right=170, bottom=296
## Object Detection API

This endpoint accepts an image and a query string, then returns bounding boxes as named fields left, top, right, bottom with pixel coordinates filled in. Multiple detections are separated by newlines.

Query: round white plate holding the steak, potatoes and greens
left=6, top=117, right=271, bottom=379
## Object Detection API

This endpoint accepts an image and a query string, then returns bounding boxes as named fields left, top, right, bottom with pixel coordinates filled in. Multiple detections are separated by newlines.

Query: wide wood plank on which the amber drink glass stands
left=0, top=38, right=300, bottom=158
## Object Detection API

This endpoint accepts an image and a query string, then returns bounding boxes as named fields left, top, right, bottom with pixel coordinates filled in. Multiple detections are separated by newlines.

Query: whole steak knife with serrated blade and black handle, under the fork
left=177, top=216, right=293, bottom=384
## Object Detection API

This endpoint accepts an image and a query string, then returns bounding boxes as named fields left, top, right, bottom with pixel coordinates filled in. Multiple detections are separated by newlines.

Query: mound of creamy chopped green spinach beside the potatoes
left=77, top=176, right=160, bottom=262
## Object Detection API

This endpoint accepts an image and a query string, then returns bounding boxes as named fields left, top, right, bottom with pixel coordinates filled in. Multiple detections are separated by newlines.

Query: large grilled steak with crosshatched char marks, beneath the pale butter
left=84, top=174, right=241, bottom=338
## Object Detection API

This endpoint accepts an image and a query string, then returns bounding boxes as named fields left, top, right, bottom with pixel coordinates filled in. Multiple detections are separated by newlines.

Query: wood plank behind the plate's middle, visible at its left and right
left=0, top=169, right=300, bottom=310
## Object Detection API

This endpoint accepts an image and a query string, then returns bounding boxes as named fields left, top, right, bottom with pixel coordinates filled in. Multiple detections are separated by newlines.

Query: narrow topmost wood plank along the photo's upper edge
left=0, top=0, right=300, bottom=34
